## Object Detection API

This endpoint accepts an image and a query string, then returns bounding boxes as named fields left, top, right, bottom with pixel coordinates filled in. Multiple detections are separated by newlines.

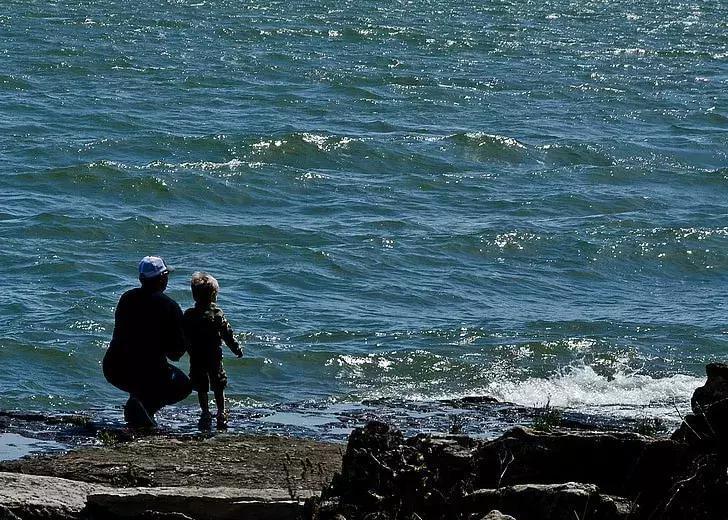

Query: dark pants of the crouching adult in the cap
left=103, top=350, right=192, bottom=415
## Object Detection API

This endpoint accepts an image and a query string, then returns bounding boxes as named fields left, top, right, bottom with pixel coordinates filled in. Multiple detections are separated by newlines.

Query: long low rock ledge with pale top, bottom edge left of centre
left=86, top=487, right=313, bottom=520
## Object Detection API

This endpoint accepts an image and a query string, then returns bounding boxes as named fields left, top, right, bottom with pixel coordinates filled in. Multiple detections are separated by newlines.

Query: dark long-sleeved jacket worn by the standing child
left=184, top=303, right=243, bottom=364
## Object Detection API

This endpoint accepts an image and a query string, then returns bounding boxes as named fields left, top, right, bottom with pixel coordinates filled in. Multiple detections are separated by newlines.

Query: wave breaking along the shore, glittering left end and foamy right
left=327, top=352, right=705, bottom=417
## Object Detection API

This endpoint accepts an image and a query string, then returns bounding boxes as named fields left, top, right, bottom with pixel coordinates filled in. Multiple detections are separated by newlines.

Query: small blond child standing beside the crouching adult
left=183, top=272, right=243, bottom=429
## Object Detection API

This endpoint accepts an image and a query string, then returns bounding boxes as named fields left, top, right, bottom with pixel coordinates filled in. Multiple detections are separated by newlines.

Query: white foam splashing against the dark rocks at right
left=488, top=365, right=705, bottom=415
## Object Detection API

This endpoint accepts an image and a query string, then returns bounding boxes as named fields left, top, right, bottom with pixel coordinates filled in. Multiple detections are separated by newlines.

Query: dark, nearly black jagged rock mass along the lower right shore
left=307, top=363, right=728, bottom=520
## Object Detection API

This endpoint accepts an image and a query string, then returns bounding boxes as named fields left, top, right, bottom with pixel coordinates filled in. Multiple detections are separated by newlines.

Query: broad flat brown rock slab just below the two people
left=0, top=434, right=345, bottom=492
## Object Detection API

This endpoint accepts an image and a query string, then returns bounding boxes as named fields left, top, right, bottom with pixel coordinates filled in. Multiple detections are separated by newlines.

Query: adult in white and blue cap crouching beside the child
left=103, top=256, right=192, bottom=427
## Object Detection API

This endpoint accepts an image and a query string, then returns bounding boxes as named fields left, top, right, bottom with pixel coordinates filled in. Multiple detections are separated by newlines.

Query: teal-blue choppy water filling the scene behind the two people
left=0, top=0, right=728, bottom=430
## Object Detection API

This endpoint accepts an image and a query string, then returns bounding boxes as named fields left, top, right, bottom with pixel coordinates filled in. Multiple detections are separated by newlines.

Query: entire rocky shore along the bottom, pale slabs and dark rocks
left=0, top=363, right=728, bottom=520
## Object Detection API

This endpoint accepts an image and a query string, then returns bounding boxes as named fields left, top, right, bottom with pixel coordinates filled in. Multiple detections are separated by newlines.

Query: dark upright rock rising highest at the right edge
left=672, top=363, right=728, bottom=451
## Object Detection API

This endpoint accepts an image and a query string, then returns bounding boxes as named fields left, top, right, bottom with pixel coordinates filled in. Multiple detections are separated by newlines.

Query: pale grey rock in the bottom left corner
left=0, top=473, right=109, bottom=520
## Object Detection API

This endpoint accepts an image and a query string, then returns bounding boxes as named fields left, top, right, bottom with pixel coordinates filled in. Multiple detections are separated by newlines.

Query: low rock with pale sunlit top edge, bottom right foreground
left=460, top=482, right=631, bottom=520
